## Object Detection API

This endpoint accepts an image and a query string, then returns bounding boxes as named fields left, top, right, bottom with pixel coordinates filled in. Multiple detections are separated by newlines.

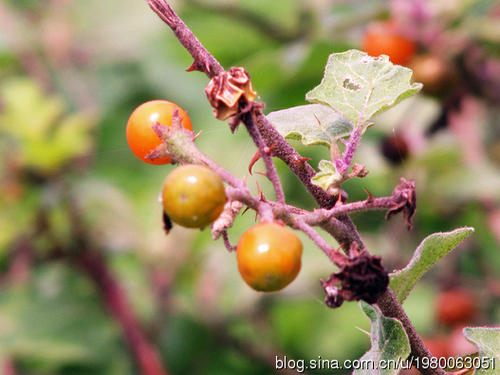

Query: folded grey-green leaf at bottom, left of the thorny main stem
left=353, top=302, right=411, bottom=375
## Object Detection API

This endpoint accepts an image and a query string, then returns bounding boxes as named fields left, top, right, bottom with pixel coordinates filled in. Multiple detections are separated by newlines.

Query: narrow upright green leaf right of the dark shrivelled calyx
left=390, top=227, right=474, bottom=303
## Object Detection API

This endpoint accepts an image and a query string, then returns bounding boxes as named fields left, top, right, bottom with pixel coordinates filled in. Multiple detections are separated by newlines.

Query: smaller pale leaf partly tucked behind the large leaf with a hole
left=267, top=104, right=352, bottom=147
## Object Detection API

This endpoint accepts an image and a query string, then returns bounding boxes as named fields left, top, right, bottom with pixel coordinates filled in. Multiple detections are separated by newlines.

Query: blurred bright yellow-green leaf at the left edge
left=0, top=78, right=94, bottom=174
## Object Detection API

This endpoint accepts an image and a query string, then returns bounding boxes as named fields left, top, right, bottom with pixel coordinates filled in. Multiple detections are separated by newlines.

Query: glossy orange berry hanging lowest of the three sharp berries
left=236, top=222, right=302, bottom=292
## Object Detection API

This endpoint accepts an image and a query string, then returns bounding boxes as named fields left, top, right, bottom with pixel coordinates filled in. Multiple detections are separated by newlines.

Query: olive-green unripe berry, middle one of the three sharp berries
left=162, top=165, right=226, bottom=228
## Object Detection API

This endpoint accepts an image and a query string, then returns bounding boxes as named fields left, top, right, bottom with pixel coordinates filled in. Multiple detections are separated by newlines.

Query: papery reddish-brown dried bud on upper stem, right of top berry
left=205, top=67, right=257, bottom=120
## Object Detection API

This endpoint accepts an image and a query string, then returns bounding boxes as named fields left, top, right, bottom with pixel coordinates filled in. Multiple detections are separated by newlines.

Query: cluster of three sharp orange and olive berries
left=127, top=100, right=302, bottom=292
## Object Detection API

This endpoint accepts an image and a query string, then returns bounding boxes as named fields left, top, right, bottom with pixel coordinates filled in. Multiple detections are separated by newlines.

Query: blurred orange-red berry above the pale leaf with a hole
left=363, top=22, right=416, bottom=65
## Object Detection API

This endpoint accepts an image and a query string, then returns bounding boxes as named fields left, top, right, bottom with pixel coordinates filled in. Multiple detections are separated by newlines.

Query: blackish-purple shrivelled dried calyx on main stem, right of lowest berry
left=321, top=252, right=389, bottom=307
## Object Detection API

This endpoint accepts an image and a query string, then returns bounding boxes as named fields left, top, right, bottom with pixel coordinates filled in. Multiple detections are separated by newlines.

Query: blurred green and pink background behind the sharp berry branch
left=0, top=0, right=500, bottom=375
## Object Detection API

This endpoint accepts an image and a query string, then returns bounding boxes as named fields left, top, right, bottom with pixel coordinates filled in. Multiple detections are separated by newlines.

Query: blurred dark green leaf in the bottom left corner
left=0, top=265, right=117, bottom=369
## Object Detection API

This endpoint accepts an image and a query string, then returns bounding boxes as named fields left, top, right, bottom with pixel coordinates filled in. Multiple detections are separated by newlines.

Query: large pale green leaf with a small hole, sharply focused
left=306, top=50, right=422, bottom=126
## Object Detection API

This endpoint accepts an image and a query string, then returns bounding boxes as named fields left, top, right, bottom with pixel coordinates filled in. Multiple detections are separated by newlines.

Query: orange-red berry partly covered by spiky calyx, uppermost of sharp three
left=127, top=100, right=192, bottom=165
